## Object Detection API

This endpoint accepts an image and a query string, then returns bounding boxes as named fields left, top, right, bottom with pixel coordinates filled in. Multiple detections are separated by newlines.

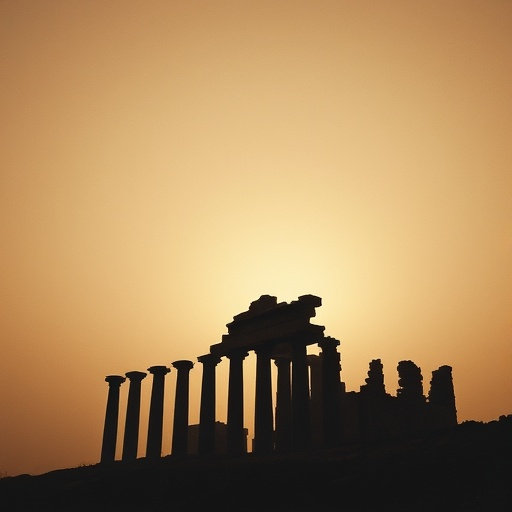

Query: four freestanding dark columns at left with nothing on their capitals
left=101, top=360, right=194, bottom=463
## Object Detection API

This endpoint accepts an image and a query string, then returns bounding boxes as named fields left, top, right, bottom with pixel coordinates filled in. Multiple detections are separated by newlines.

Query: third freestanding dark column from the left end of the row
left=146, top=366, right=171, bottom=459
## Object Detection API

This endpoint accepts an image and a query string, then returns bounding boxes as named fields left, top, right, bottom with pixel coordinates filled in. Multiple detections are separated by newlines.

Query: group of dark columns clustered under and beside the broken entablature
left=198, top=337, right=341, bottom=455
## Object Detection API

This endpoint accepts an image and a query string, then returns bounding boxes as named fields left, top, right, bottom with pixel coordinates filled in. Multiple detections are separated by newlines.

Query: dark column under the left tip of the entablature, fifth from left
left=197, top=354, right=220, bottom=455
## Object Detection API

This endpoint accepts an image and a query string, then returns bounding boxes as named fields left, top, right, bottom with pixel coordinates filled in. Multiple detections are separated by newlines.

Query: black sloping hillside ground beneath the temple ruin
left=0, top=415, right=512, bottom=512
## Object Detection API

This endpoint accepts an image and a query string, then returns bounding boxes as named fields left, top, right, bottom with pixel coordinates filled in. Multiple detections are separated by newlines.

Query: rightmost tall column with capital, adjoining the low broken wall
left=318, top=337, right=341, bottom=448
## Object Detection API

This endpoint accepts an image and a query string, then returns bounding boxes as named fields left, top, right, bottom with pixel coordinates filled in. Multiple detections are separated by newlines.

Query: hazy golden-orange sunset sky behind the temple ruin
left=0, top=0, right=512, bottom=476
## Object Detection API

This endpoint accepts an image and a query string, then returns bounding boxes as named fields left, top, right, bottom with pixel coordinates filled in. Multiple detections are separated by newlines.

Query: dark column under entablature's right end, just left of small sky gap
left=292, top=339, right=311, bottom=450
